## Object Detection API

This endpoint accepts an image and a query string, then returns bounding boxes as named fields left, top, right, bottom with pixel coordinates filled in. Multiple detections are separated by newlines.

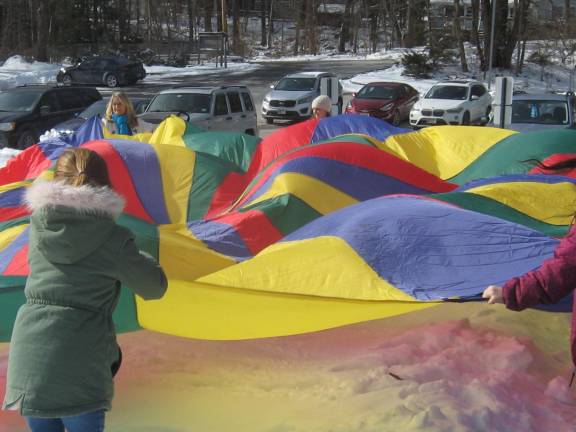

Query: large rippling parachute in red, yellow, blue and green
left=0, top=115, right=576, bottom=340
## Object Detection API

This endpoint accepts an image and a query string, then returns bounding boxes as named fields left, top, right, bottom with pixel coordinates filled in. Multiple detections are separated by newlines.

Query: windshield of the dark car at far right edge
left=512, top=99, right=569, bottom=125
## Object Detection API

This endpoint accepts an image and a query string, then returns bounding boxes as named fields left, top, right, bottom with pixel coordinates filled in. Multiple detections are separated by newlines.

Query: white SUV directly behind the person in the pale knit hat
left=262, top=72, right=343, bottom=124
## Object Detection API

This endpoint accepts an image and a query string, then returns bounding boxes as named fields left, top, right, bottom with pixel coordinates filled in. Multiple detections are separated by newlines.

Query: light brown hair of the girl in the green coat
left=54, top=148, right=112, bottom=188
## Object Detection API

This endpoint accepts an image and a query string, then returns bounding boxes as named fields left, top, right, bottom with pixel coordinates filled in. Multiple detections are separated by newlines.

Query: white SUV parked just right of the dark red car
left=410, top=81, right=492, bottom=128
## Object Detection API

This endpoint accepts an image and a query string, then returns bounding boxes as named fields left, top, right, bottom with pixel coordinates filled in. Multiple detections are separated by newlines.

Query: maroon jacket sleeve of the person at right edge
left=502, top=227, right=576, bottom=310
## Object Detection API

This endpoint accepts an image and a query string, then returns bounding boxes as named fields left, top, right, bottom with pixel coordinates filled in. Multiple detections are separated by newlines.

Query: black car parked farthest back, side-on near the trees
left=56, top=57, right=146, bottom=87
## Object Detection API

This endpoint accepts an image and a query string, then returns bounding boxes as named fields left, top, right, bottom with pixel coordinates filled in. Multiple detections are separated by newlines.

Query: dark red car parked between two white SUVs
left=346, top=82, right=419, bottom=126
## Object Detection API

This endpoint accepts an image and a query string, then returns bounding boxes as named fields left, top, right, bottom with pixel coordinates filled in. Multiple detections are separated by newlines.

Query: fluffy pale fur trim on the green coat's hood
left=25, top=181, right=124, bottom=219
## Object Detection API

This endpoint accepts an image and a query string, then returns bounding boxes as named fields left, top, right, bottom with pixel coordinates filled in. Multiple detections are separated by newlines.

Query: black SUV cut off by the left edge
left=0, top=85, right=102, bottom=149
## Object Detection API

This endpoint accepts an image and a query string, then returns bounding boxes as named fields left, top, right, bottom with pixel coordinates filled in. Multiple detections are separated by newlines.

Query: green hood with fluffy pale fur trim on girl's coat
left=25, top=181, right=124, bottom=264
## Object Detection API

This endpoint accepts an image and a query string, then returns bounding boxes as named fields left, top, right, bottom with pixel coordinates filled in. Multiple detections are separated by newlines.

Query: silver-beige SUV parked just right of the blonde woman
left=138, top=85, right=258, bottom=135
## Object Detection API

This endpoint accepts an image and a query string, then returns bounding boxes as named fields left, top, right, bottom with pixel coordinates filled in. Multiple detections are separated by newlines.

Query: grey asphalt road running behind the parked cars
left=98, top=60, right=393, bottom=136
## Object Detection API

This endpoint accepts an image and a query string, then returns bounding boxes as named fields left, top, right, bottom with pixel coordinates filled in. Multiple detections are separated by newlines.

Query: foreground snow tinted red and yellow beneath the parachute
left=0, top=303, right=576, bottom=432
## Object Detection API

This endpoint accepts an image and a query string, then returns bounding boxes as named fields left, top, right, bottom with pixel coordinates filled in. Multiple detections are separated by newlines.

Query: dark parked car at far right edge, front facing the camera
left=493, top=93, right=574, bottom=132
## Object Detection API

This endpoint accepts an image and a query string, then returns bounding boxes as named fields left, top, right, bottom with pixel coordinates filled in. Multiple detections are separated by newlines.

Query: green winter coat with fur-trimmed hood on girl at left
left=3, top=182, right=166, bottom=417
